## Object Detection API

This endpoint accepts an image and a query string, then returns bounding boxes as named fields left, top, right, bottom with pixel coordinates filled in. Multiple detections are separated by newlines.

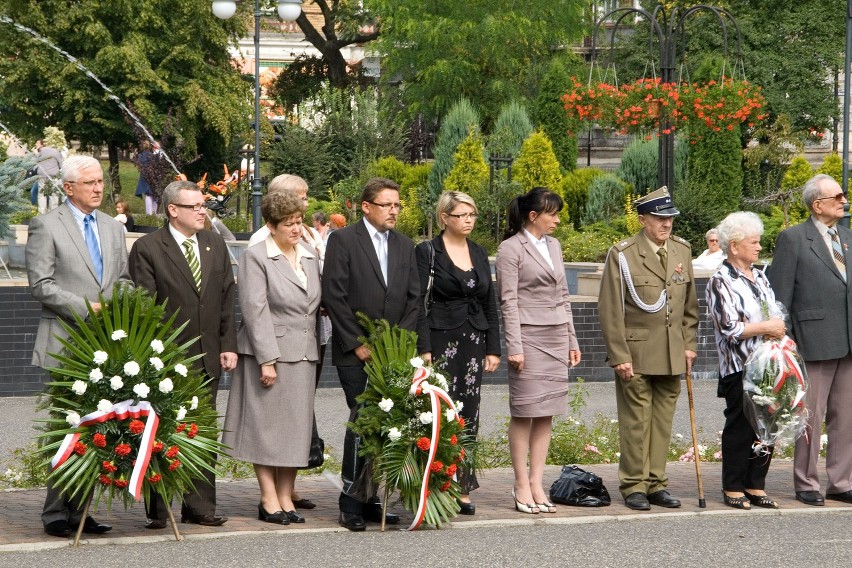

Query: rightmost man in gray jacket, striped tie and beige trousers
left=767, top=174, right=852, bottom=506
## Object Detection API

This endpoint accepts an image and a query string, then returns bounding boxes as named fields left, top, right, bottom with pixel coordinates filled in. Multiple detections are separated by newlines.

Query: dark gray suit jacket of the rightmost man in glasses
left=766, top=215, right=852, bottom=361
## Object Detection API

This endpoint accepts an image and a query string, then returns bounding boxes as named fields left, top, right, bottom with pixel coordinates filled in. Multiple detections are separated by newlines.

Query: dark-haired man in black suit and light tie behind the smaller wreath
left=322, top=178, right=420, bottom=531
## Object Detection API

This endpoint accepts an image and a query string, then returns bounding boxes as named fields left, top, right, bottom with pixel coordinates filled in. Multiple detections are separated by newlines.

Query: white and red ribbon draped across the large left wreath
left=50, top=399, right=160, bottom=501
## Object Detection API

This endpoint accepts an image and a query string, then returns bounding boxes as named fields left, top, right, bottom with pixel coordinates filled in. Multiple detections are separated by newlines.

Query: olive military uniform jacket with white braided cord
left=598, top=233, right=698, bottom=375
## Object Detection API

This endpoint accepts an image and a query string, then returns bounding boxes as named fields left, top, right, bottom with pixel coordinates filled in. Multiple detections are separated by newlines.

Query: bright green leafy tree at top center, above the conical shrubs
left=369, top=0, right=587, bottom=124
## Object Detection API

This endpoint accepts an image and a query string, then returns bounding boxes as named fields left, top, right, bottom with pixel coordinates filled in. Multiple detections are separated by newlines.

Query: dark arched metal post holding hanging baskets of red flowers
left=592, top=4, right=740, bottom=192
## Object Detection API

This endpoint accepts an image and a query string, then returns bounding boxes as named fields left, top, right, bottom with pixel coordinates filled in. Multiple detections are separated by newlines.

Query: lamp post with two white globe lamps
left=212, top=0, right=302, bottom=231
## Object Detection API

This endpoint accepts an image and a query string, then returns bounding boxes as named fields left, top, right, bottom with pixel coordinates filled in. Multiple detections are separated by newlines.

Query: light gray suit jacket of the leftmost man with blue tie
left=26, top=203, right=131, bottom=367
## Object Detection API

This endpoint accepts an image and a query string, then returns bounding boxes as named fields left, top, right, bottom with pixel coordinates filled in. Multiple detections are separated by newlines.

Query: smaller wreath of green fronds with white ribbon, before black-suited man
left=350, top=314, right=474, bottom=529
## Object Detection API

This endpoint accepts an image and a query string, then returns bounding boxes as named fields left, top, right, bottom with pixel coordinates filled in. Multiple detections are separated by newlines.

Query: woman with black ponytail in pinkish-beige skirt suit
left=497, top=187, right=580, bottom=514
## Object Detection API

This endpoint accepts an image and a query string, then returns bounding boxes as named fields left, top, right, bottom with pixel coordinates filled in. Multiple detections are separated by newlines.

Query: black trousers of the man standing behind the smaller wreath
left=337, top=365, right=377, bottom=515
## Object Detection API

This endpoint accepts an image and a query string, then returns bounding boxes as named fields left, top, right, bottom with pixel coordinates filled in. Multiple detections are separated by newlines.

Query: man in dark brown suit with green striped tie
left=130, top=181, right=237, bottom=529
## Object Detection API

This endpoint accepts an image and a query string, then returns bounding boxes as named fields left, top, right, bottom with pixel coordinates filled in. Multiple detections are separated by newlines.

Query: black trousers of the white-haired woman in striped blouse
left=717, top=372, right=773, bottom=491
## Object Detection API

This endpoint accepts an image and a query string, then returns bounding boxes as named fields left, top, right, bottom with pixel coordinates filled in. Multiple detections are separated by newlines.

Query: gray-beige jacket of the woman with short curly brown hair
left=237, top=242, right=321, bottom=363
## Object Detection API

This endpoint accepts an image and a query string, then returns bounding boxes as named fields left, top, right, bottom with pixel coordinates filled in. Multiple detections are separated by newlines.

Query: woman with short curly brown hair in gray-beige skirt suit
left=222, top=193, right=320, bottom=525
